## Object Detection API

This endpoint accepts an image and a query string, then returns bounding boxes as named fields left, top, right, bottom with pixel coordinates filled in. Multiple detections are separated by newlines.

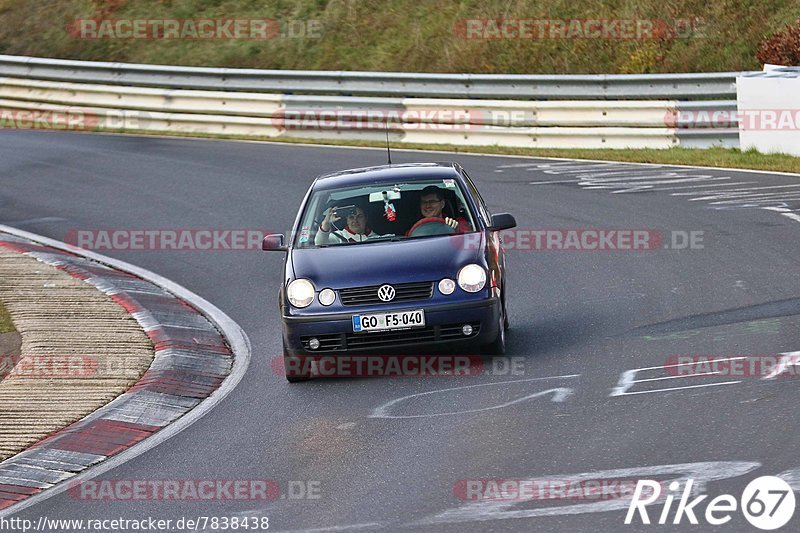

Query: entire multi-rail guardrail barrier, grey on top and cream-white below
left=0, top=56, right=738, bottom=148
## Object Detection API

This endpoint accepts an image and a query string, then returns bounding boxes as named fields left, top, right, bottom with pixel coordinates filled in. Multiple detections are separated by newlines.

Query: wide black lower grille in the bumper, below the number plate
left=300, top=322, right=481, bottom=353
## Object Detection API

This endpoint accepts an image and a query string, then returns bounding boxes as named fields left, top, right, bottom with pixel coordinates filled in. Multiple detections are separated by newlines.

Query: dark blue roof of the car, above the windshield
left=314, top=162, right=461, bottom=189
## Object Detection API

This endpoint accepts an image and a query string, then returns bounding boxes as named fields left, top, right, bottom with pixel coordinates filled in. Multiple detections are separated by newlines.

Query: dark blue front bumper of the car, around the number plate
left=282, top=297, right=501, bottom=355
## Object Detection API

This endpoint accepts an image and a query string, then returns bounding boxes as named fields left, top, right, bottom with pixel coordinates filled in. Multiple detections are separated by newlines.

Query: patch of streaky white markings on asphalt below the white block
left=495, top=161, right=800, bottom=222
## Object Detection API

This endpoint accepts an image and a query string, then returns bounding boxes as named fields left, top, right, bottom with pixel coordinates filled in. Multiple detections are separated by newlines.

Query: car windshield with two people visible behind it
left=294, top=178, right=476, bottom=248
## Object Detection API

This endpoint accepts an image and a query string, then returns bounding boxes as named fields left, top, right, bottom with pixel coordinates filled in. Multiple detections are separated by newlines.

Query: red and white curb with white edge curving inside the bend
left=0, top=225, right=250, bottom=517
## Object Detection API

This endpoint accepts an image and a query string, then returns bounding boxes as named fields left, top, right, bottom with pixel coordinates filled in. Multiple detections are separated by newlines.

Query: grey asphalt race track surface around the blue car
left=0, top=131, right=800, bottom=531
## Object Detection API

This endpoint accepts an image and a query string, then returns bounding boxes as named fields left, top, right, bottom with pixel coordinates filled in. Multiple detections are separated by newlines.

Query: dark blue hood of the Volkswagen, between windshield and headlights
left=291, top=232, right=485, bottom=289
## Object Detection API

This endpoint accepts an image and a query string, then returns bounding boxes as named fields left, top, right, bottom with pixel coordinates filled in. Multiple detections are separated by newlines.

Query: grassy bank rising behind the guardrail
left=0, top=0, right=797, bottom=74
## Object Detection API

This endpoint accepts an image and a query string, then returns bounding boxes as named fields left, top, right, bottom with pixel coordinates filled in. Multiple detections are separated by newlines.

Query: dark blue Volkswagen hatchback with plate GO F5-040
left=263, top=163, right=516, bottom=381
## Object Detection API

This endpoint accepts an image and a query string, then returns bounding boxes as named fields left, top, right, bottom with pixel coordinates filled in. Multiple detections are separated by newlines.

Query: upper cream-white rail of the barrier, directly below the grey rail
left=0, top=78, right=677, bottom=128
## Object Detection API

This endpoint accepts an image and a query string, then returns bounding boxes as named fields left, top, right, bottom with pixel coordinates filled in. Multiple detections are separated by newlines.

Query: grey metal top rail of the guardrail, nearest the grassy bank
left=0, top=55, right=749, bottom=100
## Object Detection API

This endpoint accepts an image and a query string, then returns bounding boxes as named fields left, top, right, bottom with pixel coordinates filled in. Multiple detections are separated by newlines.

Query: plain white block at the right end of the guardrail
left=736, top=76, right=800, bottom=156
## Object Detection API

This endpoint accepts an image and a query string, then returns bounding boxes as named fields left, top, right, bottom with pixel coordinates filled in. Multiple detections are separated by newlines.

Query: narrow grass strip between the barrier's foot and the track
left=97, top=128, right=800, bottom=174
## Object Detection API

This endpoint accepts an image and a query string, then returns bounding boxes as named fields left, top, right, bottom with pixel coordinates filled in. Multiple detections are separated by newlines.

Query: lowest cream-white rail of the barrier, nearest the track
left=0, top=99, right=678, bottom=148
